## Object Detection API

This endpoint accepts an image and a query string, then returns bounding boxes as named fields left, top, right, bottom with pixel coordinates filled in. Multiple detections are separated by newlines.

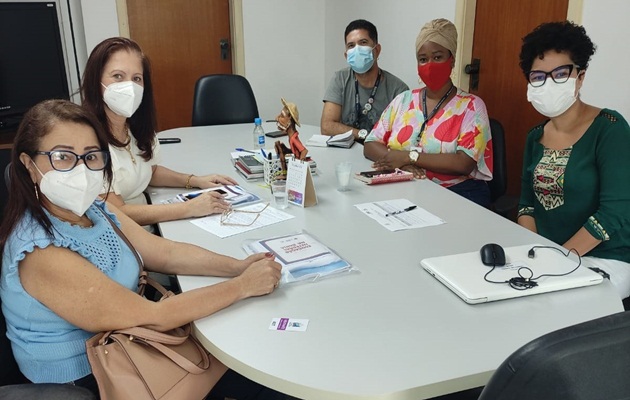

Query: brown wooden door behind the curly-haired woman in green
left=468, top=0, right=568, bottom=195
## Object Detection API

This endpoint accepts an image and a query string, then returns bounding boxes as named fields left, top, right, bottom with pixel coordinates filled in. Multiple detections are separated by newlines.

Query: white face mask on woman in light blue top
left=33, top=163, right=103, bottom=217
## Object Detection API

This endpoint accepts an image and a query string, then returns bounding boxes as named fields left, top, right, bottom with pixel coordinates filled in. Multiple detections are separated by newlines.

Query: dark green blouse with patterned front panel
left=519, top=109, right=630, bottom=262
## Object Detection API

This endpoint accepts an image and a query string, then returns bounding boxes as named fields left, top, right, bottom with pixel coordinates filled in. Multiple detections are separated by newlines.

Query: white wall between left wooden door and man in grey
left=243, top=0, right=325, bottom=125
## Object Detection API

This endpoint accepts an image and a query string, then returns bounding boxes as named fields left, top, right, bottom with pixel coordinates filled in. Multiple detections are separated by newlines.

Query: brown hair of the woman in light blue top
left=0, top=100, right=112, bottom=253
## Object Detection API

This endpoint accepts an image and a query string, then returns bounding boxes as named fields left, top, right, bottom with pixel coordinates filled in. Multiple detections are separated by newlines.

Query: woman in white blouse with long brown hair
left=81, top=37, right=236, bottom=225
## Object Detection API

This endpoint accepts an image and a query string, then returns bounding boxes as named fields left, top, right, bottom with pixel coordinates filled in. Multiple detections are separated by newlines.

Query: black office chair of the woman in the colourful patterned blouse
left=488, top=118, right=518, bottom=218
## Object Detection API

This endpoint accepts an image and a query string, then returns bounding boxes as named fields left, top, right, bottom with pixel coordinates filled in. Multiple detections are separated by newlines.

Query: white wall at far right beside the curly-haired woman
left=581, top=0, right=630, bottom=119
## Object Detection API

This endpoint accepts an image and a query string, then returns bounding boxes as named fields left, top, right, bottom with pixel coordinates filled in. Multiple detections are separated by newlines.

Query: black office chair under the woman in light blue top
left=0, top=300, right=96, bottom=400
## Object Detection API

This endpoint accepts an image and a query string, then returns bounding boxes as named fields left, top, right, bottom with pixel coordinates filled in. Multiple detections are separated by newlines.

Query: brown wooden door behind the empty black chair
left=127, top=0, right=232, bottom=131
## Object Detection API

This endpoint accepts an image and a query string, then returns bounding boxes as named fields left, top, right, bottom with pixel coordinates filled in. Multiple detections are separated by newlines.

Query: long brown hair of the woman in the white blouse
left=81, top=37, right=157, bottom=161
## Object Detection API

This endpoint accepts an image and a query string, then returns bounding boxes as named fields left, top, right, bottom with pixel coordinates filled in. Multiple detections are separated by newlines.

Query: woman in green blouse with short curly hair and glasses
left=518, top=22, right=630, bottom=298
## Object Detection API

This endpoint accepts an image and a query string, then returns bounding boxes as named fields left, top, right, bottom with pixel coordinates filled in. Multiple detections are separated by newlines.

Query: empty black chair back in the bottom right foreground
left=479, top=312, right=630, bottom=400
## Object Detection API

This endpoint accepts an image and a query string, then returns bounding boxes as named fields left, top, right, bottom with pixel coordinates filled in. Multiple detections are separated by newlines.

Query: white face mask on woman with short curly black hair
left=527, top=77, right=577, bottom=118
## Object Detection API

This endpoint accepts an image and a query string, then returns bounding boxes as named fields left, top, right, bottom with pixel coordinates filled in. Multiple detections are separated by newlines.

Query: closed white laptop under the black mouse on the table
left=421, top=245, right=603, bottom=304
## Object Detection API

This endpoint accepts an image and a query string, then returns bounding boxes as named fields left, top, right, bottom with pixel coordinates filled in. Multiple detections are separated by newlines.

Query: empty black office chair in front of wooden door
left=192, top=75, right=258, bottom=126
